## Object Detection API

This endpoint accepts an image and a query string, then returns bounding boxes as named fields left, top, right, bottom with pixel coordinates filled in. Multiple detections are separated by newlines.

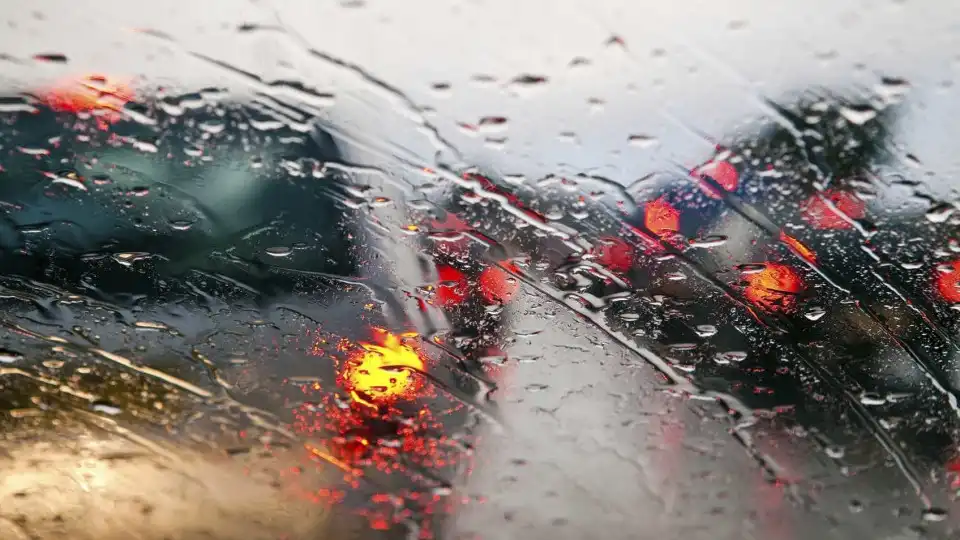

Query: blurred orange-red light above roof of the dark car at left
left=42, top=75, right=134, bottom=122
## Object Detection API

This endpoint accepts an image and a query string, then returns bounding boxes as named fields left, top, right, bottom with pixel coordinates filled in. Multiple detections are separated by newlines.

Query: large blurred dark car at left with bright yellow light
left=0, top=76, right=517, bottom=538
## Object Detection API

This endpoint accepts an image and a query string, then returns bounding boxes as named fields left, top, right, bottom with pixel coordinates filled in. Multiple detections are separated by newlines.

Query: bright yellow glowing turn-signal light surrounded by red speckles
left=342, top=330, right=424, bottom=405
